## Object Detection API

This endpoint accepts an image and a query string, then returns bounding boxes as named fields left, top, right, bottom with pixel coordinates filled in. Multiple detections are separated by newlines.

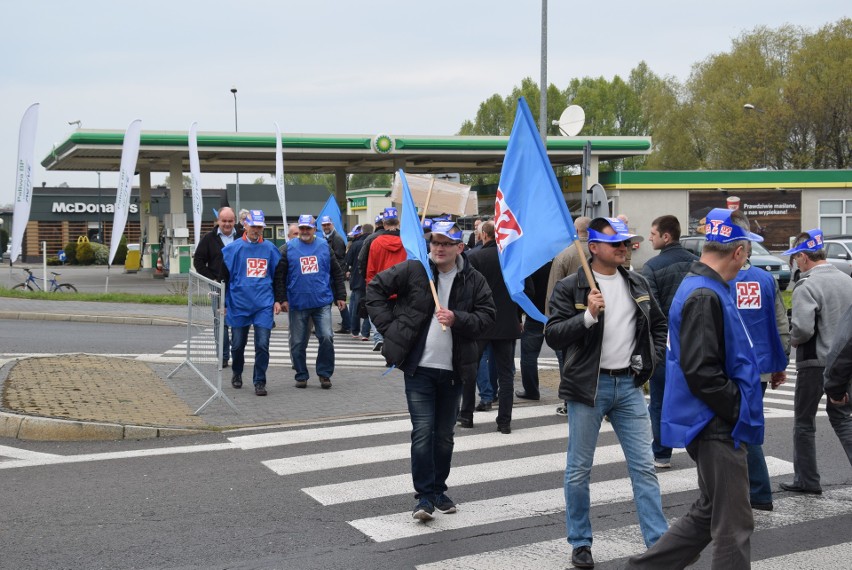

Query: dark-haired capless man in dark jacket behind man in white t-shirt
left=642, top=215, right=698, bottom=469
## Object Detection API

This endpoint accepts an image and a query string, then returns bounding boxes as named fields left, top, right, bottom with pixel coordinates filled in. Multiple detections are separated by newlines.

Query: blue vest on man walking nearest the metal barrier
left=222, top=237, right=281, bottom=329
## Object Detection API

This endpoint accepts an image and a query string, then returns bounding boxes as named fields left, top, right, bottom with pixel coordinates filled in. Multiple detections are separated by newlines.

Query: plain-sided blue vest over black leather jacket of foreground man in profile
left=660, top=275, right=763, bottom=447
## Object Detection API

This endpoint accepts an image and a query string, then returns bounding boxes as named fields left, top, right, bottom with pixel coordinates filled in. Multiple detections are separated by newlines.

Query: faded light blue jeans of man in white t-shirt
left=565, top=374, right=669, bottom=548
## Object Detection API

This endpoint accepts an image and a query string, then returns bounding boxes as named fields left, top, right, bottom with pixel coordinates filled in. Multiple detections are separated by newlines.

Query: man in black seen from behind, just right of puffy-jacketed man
left=459, top=222, right=521, bottom=434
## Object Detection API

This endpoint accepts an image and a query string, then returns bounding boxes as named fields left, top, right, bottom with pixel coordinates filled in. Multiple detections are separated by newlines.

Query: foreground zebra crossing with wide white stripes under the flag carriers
left=228, top=402, right=852, bottom=570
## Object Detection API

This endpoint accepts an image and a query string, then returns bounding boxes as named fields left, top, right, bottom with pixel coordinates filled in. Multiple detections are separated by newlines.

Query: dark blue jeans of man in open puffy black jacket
left=405, top=366, right=462, bottom=501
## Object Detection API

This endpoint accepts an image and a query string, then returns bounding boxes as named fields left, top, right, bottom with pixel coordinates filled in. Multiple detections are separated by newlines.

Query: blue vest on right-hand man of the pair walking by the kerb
left=287, top=238, right=334, bottom=311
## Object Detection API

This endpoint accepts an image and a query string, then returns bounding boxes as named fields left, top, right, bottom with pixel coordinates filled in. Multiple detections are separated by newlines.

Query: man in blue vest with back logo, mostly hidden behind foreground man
left=730, top=242, right=790, bottom=511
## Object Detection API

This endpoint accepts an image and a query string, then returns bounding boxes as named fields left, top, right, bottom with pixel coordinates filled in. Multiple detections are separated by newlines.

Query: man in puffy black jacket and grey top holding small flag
left=367, top=222, right=495, bottom=521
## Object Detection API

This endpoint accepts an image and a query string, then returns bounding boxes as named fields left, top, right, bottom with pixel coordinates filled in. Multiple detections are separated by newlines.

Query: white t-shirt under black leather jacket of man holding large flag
left=586, top=271, right=636, bottom=370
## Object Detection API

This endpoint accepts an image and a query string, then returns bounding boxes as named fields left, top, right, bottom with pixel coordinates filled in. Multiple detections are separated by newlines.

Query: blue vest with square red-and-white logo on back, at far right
left=729, top=265, right=789, bottom=374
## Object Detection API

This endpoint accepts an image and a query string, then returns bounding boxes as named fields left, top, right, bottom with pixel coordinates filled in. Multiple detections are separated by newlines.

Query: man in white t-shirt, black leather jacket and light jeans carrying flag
left=544, top=218, right=668, bottom=568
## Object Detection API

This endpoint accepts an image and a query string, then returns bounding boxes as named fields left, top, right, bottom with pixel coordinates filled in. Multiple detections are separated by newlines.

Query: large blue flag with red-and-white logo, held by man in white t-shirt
left=494, top=97, right=577, bottom=322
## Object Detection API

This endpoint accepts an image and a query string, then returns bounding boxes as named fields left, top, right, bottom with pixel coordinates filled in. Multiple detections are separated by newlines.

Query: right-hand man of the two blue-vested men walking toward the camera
left=275, top=214, right=346, bottom=390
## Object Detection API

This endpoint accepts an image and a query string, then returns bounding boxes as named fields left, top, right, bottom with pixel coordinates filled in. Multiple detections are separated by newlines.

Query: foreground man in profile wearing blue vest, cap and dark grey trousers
left=626, top=208, right=763, bottom=570
